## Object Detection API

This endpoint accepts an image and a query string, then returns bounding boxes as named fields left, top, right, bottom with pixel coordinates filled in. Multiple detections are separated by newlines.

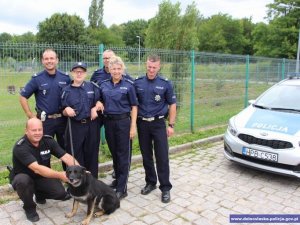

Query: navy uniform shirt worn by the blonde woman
left=100, top=77, right=138, bottom=114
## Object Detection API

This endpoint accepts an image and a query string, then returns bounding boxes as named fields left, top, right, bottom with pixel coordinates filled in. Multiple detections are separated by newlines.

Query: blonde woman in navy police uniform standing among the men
left=100, top=56, right=138, bottom=199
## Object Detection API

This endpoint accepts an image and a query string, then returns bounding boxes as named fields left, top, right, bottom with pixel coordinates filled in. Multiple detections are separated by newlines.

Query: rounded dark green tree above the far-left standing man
left=37, top=13, right=87, bottom=44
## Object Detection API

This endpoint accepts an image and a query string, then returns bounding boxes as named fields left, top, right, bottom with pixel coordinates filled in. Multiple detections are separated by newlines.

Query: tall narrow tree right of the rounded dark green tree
left=89, top=0, right=104, bottom=28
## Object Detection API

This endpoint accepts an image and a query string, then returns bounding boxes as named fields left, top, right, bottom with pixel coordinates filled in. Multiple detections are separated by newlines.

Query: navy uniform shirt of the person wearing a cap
left=61, top=81, right=100, bottom=120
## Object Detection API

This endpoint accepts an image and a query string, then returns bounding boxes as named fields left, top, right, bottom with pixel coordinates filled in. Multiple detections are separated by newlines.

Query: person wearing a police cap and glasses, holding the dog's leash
left=61, top=62, right=103, bottom=178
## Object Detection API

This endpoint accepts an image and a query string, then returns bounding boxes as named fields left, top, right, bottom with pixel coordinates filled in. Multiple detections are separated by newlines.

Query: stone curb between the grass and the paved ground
left=0, top=134, right=224, bottom=194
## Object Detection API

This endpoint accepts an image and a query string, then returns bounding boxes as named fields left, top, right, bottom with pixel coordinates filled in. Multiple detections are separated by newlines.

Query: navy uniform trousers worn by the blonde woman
left=104, top=118, right=132, bottom=193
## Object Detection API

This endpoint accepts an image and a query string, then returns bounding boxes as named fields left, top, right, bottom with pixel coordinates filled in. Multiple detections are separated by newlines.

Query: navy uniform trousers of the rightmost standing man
left=137, top=119, right=172, bottom=191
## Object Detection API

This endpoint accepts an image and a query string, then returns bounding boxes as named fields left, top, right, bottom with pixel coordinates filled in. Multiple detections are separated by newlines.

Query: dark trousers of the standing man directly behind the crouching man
left=43, top=117, right=67, bottom=149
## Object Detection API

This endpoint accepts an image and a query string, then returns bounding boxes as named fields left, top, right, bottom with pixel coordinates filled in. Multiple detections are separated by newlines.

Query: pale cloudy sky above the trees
left=0, top=0, right=274, bottom=35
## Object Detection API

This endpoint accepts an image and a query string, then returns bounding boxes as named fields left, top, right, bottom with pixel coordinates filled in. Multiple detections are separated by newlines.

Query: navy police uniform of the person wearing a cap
left=61, top=81, right=100, bottom=178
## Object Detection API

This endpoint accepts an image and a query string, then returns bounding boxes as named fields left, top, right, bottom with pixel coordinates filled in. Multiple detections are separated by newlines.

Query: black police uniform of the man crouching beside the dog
left=12, top=135, right=68, bottom=214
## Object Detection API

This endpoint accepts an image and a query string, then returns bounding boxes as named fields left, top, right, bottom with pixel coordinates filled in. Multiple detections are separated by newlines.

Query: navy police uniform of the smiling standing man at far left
left=20, top=70, right=71, bottom=148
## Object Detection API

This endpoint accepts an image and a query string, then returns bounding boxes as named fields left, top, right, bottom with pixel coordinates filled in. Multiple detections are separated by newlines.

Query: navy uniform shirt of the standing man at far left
left=20, top=70, right=71, bottom=114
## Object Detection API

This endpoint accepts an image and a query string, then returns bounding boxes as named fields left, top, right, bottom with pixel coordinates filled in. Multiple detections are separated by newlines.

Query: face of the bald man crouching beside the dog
left=25, top=118, right=43, bottom=146
